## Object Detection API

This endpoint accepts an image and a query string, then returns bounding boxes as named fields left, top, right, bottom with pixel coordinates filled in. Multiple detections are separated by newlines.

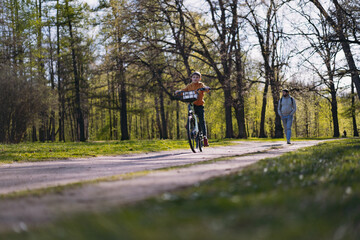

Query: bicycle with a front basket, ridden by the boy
left=175, top=88, right=206, bottom=153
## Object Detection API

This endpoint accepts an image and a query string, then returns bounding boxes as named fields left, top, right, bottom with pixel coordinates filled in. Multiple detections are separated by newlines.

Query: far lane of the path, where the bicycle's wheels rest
left=0, top=141, right=286, bottom=194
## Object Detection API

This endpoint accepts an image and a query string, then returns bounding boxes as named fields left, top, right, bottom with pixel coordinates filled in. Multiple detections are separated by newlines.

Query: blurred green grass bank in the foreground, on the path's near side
left=0, top=139, right=360, bottom=240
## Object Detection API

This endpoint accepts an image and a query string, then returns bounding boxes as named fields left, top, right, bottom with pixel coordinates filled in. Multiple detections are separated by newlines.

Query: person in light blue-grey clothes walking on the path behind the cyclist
left=278, top=89, right=296, bottom=144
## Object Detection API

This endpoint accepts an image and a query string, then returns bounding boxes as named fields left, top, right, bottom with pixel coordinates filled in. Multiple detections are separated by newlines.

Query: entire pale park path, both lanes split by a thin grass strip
left=0, top=141, right=328, bottom=231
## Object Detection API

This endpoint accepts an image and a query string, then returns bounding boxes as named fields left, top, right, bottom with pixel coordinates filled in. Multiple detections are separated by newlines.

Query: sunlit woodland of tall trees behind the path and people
left=0, top=0, right=360, bottom=143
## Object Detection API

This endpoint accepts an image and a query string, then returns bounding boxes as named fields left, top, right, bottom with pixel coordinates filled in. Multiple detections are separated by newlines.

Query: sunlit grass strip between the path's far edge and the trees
left=0, top=140, right=236, bottom=163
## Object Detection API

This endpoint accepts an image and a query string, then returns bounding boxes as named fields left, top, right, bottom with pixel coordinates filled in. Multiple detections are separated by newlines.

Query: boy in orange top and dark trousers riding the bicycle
left=175, top=72, right=210, bottom=147
